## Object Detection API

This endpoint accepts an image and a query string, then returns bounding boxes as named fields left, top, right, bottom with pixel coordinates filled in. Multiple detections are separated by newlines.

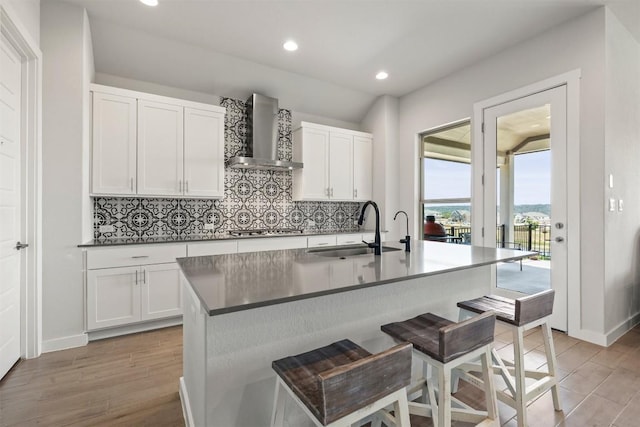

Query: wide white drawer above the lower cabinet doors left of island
left=87, top=244, right=187, bottom=270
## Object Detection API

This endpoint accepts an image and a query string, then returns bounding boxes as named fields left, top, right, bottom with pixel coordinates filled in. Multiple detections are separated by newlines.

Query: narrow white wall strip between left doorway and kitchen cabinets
left=40, top=2, right=87, bottom=351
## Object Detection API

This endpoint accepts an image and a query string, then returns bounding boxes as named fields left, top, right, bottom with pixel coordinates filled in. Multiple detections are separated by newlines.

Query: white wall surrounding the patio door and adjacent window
left=398, top=8, right=605, bottom=334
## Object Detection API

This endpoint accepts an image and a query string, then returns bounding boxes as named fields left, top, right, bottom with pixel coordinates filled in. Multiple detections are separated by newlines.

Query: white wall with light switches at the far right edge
left=604, top=10, right=640, bottom=338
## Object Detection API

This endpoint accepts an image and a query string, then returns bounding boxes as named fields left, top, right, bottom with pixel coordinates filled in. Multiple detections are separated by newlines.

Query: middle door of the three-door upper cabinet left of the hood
left=138, top=100, right=184, bottom=196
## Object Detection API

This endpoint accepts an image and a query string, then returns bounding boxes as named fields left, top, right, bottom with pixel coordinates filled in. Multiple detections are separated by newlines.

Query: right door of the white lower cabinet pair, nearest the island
left=140, top=262, right=182, bottom=320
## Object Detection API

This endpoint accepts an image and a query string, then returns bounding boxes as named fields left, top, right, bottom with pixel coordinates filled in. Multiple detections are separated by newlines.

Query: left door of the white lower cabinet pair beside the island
left=87, top=267, right=141, bottom=330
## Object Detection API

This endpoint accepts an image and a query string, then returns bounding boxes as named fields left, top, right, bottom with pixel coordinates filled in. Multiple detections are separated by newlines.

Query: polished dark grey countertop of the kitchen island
left=177, top=241, right=535, bottom=316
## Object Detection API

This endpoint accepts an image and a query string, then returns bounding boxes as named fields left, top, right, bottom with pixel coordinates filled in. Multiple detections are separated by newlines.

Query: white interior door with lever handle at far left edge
left=0, top=36, right=22, bottom=378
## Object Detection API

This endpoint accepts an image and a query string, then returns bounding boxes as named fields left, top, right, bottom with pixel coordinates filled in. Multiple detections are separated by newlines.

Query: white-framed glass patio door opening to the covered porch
left=483, top=86, right=570, bottom=331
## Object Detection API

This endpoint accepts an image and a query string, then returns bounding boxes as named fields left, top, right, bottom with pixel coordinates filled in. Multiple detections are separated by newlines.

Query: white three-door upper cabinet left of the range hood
left=91, top=85, right=225, bottom=198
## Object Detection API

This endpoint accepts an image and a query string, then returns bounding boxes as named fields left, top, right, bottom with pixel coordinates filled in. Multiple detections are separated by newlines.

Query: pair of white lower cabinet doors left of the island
left=87, top=262, right=182, bottom=331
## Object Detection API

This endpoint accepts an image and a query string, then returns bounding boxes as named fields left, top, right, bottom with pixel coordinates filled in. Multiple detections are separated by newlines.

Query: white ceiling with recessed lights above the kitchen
left=60, top=0, right=624, bottom=122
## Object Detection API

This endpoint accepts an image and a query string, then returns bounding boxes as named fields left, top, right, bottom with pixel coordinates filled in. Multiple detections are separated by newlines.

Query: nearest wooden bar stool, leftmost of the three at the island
left=271, top=340, right=411, bottom=426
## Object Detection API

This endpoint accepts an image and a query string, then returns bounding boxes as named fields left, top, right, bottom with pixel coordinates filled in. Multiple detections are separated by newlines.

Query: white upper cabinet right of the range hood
left=293, top=122, right=373, bottom=201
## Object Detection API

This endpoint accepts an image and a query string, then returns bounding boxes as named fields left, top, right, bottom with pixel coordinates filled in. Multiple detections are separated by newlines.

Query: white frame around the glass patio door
left=471, top=69, right=580, bottom=341
